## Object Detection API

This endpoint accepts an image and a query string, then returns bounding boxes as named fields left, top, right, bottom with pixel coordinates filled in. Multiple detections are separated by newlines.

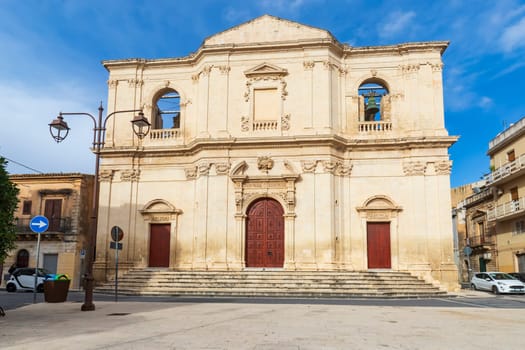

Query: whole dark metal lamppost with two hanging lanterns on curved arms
left=49, top=103, right=151, bottom=311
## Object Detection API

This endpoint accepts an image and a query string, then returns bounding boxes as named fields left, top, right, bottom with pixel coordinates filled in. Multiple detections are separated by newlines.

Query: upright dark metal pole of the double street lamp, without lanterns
left=80, top=104, right=104, bottom=311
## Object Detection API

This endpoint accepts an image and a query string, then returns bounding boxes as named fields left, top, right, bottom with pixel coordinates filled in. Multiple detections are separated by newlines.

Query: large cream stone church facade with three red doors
left=94, top=15, right=458, bottom=290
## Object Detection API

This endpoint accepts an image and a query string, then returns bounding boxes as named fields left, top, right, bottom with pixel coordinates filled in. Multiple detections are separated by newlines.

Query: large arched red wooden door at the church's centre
left=246, top=198, right=284, bottom=267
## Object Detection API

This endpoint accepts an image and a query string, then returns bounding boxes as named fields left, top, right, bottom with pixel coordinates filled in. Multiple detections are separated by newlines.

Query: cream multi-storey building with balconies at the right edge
left=486, top=117, right=525, bottom=272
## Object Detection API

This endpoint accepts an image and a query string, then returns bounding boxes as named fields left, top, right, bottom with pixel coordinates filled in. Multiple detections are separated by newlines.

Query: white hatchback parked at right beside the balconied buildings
left=470, top=272, right=525, bottom=294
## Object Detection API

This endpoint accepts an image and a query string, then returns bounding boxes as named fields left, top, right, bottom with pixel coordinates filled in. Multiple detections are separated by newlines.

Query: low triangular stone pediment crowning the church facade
left=203, top=15, right=335, bottom=46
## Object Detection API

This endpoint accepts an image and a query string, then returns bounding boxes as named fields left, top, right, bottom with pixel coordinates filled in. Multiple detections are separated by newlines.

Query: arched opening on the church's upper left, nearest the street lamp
left=153, top=90, right=180, bottom=129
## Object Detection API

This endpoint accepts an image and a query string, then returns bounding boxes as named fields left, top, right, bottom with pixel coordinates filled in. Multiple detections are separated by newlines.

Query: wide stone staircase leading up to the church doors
left=95, top=268, right=447, bottom=298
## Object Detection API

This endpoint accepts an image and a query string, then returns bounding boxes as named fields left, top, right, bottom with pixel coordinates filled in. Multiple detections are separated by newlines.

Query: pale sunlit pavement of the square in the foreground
left=0, top=291, right=525, bottom=350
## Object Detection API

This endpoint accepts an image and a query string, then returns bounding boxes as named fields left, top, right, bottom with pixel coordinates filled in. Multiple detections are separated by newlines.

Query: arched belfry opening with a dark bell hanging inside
left=358, top=79, right=390, bottom=122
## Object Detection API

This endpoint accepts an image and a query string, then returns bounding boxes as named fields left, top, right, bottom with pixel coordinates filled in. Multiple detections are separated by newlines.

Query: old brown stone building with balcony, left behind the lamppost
left=4, top=174, right=94, bottom=288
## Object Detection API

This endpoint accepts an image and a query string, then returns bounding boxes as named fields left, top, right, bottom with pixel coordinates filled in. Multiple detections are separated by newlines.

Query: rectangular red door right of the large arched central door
left=366, top=222, right=392, bottom=269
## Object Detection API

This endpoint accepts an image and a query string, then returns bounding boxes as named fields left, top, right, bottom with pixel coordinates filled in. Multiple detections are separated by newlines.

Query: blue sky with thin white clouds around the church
left=0, top=0, right=525, bottom=186
